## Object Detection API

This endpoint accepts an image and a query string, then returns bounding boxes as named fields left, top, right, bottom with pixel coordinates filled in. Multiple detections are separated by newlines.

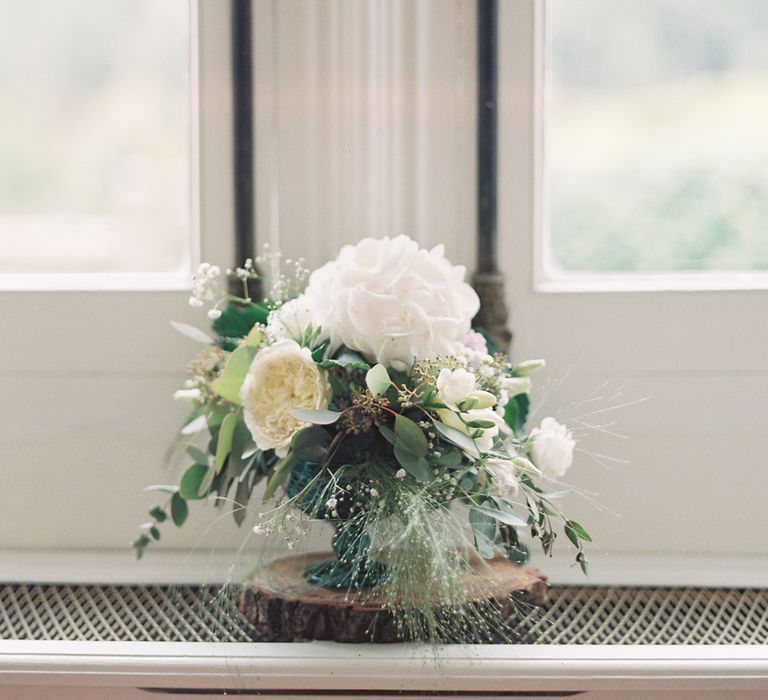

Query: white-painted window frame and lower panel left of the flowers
left=0, top=0, right=234, bottom=560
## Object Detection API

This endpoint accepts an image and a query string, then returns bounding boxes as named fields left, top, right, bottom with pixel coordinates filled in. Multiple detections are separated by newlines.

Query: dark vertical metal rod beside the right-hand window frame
left=477, top=0, right=498, bottom=272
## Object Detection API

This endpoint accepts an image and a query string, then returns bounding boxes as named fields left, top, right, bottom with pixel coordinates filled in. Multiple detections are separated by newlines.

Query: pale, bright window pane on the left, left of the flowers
left=0, top=0, right=191, bottom=273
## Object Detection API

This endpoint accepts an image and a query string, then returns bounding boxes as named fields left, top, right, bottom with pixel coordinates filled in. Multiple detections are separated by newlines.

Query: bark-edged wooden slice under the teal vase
left=238, top=553, right=547, bottom=642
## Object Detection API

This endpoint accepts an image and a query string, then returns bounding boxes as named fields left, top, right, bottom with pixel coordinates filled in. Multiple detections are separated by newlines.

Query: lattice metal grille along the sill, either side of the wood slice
left=0, top=585, right=768, bottom=644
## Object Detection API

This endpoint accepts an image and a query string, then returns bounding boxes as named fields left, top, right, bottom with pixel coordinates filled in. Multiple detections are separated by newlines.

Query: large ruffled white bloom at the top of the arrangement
left=304, top=236, right=480, bottom=370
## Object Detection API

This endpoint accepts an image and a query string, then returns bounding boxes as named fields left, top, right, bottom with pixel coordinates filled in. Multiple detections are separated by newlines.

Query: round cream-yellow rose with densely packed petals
left=240, top=339, right=331, bottom=456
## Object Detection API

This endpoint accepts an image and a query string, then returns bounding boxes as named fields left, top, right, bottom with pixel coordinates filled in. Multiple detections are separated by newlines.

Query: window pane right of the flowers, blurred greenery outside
left=546, top=0, right=768, bottom=272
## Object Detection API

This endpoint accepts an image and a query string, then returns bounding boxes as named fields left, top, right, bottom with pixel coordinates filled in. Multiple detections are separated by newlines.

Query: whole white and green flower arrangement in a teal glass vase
left=133, top=236, right=590, bottom=638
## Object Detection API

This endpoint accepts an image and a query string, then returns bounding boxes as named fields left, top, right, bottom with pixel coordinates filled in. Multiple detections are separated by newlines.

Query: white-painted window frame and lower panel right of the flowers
left=499, top=0, right=768, bottom=585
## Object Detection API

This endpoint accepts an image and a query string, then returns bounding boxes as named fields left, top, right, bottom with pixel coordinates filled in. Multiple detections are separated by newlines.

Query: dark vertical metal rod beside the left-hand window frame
left=231, top=0, right=256, bottom=265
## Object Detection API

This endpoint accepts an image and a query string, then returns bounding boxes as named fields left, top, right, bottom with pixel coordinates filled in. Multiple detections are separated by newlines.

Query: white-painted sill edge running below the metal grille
left=0, top=641, right=768, bottom=694
